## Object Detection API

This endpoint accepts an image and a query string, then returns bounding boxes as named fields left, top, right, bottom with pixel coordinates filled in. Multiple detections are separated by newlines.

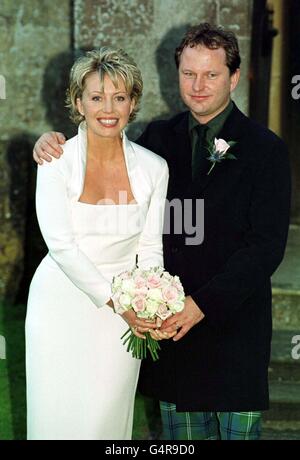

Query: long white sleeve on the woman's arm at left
left=36, top=158, right=111, bottom=307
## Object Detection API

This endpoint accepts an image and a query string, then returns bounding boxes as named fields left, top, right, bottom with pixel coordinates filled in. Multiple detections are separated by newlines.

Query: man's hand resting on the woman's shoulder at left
left=33, top=131, right=66, bottom=165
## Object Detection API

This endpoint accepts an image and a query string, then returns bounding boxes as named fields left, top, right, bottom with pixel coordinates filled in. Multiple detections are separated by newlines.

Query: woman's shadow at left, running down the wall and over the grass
left=3, top=52, right=76, bottom=439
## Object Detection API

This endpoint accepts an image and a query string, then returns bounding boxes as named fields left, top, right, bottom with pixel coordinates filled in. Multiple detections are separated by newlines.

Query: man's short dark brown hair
left=175, top=22, right=241, bottom=75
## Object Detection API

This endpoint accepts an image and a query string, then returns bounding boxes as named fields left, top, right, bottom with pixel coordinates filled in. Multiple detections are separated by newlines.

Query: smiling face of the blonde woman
left=77, top=72, right=134, bottom=138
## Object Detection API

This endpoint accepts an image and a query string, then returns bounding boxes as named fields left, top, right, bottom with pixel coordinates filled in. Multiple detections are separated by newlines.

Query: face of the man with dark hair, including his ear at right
left=179, top=45, right=240, bottom=123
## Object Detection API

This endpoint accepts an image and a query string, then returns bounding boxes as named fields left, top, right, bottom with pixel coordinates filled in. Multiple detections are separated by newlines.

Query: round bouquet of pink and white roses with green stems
left=112, top=267, right=185, bottom=361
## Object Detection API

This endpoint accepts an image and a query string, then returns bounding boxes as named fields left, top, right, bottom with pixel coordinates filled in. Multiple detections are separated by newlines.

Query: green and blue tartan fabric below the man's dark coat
left=160, top=401, right=261, bottom=441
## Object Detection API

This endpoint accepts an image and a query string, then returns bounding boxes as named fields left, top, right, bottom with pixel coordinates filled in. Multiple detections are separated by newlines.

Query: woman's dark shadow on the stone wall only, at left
left=12, top=52, right=76, bottom=303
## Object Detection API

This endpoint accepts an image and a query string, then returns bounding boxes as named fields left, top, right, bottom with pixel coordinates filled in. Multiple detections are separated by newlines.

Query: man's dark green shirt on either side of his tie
left=189, top=101, right=233, bottom=167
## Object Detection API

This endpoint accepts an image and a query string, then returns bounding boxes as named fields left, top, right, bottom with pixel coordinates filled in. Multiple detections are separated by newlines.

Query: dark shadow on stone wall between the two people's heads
left=127, top=24, right=190, bottom=139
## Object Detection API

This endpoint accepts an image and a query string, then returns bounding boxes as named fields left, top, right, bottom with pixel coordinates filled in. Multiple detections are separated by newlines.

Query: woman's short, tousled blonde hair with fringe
left=66, top=47, right=143, bottom=124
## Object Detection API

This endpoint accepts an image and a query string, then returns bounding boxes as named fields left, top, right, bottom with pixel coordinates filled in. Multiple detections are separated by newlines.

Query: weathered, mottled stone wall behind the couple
left=0, top=0, right=252, bottom=300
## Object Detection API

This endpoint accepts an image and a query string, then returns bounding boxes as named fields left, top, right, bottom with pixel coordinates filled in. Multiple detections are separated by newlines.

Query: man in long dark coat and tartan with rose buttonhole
left=35, top=24, right=290, bottom=440
